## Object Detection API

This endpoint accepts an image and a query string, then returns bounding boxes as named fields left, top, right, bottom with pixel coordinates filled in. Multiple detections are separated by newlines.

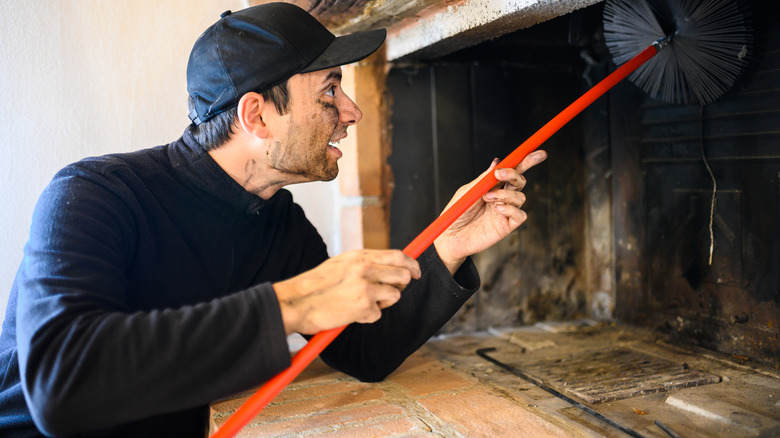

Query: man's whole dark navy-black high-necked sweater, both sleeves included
left=0, top=132, right=479, bottom=437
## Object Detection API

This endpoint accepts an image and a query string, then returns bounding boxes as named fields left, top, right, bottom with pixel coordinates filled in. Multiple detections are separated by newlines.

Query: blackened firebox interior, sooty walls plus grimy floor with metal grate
left=388, top=2, right=780, bottom=436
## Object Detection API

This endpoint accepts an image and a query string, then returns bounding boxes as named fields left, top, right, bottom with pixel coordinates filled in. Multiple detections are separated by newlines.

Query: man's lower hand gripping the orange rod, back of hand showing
left=273, top=250, right=421, bottom=335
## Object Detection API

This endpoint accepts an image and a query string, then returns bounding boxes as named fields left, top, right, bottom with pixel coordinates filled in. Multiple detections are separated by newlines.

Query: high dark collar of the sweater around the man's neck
left=168, top=130, right=274, bottom=214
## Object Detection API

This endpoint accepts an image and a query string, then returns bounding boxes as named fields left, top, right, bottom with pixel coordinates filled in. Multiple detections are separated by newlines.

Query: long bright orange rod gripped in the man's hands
left=212, top=45, right=658, bottom=438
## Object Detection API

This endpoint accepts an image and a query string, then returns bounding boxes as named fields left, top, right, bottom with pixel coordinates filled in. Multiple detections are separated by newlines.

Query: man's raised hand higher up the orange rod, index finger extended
left=433, top=151, right=547, bottom=274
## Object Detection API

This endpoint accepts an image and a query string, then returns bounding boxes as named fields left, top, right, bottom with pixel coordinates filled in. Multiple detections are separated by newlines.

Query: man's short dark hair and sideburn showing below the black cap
left=187, top=80, right=290, bottom=151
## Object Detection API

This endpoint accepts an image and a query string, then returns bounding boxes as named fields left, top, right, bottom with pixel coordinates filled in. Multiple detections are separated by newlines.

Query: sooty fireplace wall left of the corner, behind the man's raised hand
left=388, top=9, right=587, bottom=331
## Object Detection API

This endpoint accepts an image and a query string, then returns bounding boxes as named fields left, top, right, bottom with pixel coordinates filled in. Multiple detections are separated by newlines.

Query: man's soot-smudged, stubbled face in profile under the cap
left=267, top=67, right=362, bottom=181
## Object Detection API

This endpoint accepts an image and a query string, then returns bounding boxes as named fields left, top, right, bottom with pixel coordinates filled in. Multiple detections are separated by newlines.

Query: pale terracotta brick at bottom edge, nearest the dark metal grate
left=417, top=389, right=568, bottom=438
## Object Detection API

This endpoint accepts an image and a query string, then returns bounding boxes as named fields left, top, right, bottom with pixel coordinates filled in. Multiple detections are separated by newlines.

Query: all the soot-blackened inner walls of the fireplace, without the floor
left=388, top=4, right=780, bottom=364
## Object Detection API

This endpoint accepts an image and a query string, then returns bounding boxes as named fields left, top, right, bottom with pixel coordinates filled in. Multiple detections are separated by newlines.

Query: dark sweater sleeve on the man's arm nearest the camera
left=17, top=169, right=290, bottom=435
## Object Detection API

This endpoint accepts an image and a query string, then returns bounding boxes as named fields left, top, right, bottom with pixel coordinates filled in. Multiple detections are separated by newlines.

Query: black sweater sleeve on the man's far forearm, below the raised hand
left=314, top=246, right=479, bottom=382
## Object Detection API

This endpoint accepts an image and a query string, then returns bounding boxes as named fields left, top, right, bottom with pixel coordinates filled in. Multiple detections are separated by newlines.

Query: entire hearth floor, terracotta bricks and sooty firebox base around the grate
left=211, top=325, right=780, bottom=438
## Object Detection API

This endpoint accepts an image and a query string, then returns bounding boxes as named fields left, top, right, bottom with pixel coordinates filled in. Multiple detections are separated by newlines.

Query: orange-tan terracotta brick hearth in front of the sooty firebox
left=211, top=347, right=567, bottom=437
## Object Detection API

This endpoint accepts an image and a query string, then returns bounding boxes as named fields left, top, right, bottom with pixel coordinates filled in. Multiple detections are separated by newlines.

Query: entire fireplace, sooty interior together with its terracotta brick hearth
left=211, top=1, right=780, bottom=437
